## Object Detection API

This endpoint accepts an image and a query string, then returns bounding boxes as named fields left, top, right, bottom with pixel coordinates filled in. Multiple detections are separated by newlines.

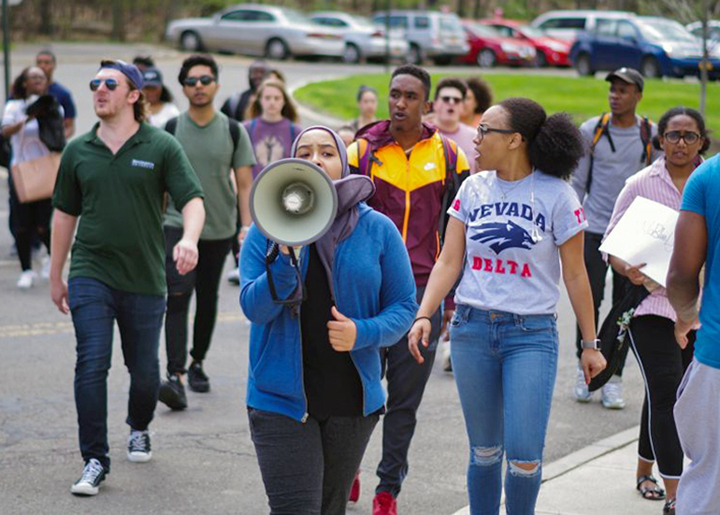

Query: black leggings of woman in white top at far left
left=10, top=181, right=52, bottom=272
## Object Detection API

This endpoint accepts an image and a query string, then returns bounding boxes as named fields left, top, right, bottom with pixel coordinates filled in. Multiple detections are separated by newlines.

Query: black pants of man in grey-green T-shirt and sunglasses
left=165, top=227, right=232, bottom=374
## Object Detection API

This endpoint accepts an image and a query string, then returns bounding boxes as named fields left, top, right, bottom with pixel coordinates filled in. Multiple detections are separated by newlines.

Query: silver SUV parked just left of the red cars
left=373, top=10, right=470, bottom=64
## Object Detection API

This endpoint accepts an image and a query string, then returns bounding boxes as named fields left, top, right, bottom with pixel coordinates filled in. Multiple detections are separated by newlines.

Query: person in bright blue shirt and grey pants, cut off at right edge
left=667, top=134, right=720, bottom=515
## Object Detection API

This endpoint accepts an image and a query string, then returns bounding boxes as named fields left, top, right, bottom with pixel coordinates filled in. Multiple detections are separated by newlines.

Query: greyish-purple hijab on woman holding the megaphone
left=290, top=125, right=375, bottom=302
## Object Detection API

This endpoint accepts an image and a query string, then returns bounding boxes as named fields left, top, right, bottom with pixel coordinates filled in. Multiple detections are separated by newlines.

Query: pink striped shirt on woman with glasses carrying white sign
left=605, top=156, right=682, bottom=322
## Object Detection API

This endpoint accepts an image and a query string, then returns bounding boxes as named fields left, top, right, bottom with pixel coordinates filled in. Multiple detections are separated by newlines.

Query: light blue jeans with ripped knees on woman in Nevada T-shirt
left=450, top=305, right=558, bottom=515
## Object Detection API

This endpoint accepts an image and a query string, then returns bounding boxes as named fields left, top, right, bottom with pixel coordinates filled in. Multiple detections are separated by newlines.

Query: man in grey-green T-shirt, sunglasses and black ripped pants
left=158, top=55, right=255, bottom=410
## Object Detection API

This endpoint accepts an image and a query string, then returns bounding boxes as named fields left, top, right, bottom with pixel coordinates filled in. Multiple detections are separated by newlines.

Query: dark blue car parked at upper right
left=570, top=15, right=720, bottom=80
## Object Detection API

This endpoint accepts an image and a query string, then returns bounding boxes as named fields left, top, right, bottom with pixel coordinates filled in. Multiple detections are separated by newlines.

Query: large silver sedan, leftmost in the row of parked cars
left=165, top=4, right=345, bottom=59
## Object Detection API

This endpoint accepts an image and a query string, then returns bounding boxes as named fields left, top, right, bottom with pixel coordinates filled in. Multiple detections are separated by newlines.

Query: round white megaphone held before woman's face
left=250, top=158, right=338, bottom=247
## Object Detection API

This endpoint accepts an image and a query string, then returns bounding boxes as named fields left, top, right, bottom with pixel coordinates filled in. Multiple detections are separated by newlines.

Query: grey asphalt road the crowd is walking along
left=0, top=45, right=642, bottom=515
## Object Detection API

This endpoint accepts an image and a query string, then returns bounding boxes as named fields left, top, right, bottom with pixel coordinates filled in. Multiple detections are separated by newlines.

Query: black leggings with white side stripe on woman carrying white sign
left=630, top=315, right=695, bottom=479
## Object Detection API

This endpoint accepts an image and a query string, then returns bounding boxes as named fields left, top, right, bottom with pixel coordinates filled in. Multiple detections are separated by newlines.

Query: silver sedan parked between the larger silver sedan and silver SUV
left=310, top=11, right=410, bottom=63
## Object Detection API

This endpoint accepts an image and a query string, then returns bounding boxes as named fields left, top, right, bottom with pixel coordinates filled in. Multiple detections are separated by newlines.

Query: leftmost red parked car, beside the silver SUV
left=460, top=20, right=536, bottom=68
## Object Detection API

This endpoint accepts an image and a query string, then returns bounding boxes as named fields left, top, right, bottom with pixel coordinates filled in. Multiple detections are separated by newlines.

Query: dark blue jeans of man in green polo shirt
left=68, top=277, right=165, bottom=468
